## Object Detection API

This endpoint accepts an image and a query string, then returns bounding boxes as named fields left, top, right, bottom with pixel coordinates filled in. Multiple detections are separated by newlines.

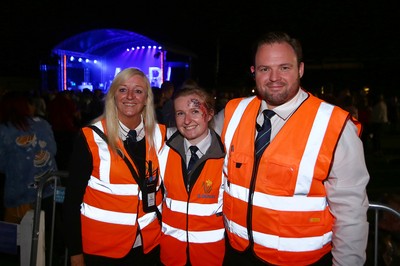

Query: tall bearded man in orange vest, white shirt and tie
left=219, top=32, right=369, bottom=265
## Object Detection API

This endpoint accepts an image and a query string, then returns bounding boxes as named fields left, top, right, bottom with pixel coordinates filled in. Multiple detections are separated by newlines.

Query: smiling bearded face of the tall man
left=251, top=42, right=304, bottom=108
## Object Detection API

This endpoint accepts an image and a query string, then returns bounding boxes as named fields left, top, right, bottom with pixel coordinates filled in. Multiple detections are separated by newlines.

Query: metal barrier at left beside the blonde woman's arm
left=30, top=171, right=68, bottom=266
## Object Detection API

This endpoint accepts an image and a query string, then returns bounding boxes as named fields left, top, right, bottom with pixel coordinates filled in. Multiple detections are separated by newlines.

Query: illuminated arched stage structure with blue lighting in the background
left=46, top=29, right=196, bottom=91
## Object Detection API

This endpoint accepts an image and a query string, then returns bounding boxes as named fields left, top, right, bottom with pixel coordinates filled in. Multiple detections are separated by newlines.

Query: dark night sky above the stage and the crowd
left=0, top=0, right=400, bottom=93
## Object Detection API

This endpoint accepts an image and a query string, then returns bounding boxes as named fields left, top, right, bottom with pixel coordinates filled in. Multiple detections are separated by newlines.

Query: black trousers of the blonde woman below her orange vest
left=84, top=246, right=161, bottom=266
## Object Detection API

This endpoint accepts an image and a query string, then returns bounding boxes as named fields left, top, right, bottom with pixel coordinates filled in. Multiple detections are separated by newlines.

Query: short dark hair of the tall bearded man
left=252, top=31, right=303, bottom=65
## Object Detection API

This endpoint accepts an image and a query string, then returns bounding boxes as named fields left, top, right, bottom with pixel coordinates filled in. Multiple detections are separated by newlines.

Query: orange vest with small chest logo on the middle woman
left=159, top=142, right=225, bottom=266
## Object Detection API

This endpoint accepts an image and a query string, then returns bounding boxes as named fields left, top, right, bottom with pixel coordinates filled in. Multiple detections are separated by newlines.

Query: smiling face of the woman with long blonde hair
left=115, top=75, right=147, bottom=127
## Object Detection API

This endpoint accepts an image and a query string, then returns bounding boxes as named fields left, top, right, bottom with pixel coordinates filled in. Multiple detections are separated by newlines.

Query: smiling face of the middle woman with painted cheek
left=174, top=94, right=213, bottom=145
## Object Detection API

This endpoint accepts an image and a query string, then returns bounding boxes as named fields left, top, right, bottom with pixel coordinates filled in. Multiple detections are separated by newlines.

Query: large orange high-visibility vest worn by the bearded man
left=222, top=94, right=361, bottom=265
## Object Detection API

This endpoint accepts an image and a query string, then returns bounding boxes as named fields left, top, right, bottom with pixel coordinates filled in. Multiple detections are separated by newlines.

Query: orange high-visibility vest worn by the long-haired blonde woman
left=81, top=120, right=165, bottom=258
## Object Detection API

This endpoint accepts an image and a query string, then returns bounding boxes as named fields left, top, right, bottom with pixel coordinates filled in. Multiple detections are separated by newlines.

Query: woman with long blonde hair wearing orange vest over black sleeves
left=64, top=68, right=166, bottom=266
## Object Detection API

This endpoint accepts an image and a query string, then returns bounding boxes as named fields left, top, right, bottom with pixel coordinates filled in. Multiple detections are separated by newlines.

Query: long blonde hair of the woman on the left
left=97, top=67, right=156, bottom=152
